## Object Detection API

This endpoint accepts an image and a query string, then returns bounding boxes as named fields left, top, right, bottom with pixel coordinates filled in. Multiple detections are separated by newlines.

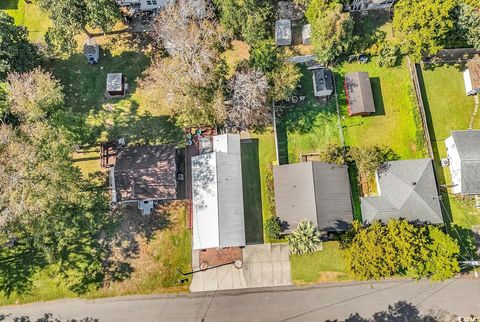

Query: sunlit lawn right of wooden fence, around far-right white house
left=419, top=65, right=480, bottom=236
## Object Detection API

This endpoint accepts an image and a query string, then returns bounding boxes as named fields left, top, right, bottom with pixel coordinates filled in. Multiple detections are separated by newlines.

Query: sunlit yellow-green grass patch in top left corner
left=0, top=0, right=51, bottom=42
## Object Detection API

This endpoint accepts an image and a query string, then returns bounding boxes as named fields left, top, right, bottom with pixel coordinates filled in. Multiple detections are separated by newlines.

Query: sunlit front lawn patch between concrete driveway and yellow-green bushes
left=290, top=241, right=348, bottom=285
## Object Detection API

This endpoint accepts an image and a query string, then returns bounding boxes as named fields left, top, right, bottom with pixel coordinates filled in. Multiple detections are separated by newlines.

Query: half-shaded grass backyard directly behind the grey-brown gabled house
left=277, top=66, right=340, bottom=164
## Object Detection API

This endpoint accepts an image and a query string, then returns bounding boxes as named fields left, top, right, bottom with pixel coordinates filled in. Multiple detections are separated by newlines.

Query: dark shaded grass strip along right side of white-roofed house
left=242, top=139, right=263, bottom=244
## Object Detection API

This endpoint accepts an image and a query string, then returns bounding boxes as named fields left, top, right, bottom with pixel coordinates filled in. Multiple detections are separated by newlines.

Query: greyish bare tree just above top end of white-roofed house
left=226, top=69, right=272, bottom=132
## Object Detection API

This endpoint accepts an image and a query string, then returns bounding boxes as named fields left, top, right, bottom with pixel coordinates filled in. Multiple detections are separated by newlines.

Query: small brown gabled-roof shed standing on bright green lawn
left=344, top=72, right=375, bottom=116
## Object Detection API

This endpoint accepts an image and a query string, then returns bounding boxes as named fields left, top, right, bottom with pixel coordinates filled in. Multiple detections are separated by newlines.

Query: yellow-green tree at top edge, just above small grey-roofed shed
left=306, top=0, right=354, bottom=63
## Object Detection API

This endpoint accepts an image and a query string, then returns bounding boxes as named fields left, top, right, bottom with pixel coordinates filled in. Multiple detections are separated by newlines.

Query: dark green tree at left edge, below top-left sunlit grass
left=0, top=11, right=40, bottom=80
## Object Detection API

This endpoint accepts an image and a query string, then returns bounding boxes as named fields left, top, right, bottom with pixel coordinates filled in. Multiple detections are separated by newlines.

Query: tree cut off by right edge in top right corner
left=458, top=2, right=480, bottom=50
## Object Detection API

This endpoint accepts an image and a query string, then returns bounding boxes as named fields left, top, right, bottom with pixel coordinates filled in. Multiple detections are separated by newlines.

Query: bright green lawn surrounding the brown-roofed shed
left=335, top=58, right=427, bottom=159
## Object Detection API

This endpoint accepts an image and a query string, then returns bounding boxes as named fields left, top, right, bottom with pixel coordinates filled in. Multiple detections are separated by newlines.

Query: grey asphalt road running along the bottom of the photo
left=0, top=279, right=480, bottom=322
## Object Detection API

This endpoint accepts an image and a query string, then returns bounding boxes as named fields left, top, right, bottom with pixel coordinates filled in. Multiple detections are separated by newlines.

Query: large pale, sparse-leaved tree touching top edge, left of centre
left=151, top=0, right=228, bottom=82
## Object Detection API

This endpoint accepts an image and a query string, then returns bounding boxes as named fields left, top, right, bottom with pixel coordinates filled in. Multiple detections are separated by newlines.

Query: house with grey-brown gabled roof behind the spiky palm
left=273, top=161, right=353, bottom=233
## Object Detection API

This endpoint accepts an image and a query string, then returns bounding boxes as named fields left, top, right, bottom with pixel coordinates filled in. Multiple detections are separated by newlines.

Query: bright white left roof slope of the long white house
left=192, top=153, right=219, bottom=249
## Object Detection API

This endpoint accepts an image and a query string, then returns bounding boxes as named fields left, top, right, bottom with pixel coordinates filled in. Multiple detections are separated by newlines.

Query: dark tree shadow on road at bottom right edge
left=326, top=301, right=455, bottom=322
